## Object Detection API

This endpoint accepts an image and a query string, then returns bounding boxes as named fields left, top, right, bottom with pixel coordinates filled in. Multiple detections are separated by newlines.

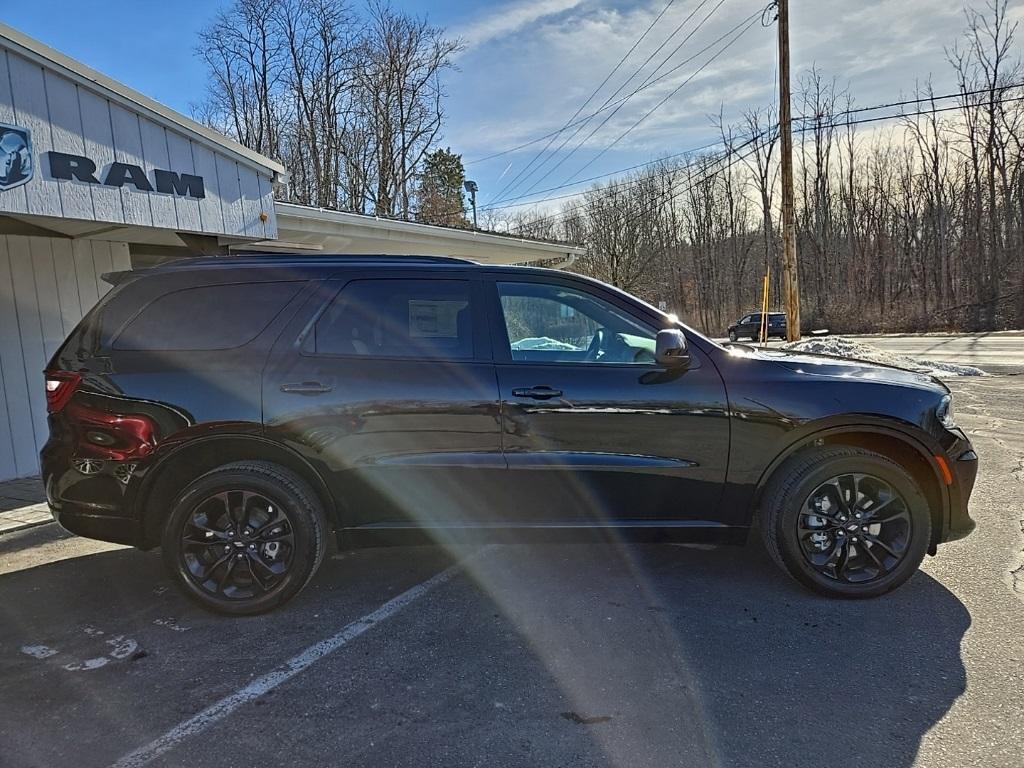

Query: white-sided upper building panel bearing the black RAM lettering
left=0, top=41, right=278, bottom=240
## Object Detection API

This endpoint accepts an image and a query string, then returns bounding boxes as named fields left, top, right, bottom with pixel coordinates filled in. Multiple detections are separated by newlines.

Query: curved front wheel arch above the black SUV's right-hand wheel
left=750, top=424, right=949, bottom=555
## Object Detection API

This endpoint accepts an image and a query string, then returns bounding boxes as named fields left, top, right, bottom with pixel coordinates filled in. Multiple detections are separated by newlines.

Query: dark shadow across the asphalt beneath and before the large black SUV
left=0, top=531, right=971, bottom=768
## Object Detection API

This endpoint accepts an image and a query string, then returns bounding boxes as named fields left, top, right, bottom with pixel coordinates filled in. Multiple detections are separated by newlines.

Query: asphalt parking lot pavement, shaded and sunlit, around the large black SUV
left=0, top=376, right=1024, bottom=768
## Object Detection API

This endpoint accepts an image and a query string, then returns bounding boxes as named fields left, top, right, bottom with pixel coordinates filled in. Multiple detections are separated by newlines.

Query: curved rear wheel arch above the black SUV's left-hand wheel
left=135, top=433, right=338, bottom=549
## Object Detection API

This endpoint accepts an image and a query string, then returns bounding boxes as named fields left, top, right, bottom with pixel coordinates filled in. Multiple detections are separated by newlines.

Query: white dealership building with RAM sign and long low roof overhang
left=0, top=25, right=580, bottom=480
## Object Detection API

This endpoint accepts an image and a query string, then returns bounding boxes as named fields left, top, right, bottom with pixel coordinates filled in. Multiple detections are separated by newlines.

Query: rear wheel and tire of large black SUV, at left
left=161, top=461, right=328, bottom=615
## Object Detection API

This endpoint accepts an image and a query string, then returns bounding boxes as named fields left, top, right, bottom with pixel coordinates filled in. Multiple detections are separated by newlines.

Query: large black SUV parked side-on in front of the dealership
left=42, top=256, right=977, bottom=614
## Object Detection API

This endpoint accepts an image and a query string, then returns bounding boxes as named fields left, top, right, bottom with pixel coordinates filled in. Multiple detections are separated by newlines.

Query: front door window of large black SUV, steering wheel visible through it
left=498, top=283, right=656, bottom=365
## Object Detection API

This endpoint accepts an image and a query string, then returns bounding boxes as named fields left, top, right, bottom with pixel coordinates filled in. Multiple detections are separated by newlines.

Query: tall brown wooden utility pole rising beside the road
left=776, top=0, right=800, bottom=341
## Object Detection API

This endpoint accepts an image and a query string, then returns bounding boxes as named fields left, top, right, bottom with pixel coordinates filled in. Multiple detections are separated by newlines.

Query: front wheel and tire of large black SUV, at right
left=759, top=447, right=932, bottom=599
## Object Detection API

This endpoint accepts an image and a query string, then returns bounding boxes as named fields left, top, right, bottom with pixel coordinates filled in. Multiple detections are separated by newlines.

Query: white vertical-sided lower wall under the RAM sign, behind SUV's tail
left=0, top=234, right=130, bottom=480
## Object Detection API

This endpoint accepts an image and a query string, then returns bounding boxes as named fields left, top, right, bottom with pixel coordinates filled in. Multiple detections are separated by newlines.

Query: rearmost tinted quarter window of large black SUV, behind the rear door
left=114, top=283, right=301, bottom=351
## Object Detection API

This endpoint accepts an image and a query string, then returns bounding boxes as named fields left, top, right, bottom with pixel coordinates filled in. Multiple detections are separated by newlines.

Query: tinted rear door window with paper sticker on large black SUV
left=307, top=280, right=473, bottom=359
